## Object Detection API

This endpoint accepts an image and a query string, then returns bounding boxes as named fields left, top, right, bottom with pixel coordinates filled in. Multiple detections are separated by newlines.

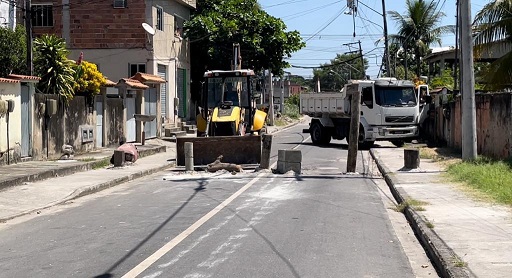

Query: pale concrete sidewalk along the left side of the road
left=0, top=139, right=176, bottom=222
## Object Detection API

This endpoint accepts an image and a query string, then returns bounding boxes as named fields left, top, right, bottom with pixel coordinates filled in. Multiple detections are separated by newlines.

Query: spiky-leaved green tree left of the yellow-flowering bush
left=34, top=35, right=75, bottom=102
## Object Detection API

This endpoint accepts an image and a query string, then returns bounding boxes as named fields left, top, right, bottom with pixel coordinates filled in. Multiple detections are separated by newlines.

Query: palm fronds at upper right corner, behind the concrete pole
left=473, top=0, right=512, bottom=89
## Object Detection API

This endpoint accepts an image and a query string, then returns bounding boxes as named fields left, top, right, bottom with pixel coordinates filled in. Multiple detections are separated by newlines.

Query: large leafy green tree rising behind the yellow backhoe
left=184, top=0, right=305, bottom=99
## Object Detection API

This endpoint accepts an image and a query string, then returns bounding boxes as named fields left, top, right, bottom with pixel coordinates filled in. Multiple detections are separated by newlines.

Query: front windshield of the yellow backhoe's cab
left=208, top=77, right=249, bottom=108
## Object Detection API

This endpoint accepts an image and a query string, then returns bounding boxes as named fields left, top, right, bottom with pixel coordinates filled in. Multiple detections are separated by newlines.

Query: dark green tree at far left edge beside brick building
left=0, top=25, right=27, bottom=77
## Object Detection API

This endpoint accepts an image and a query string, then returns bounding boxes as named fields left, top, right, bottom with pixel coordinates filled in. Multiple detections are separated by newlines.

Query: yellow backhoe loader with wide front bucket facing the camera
left=176, top=44, right=267, bottom=165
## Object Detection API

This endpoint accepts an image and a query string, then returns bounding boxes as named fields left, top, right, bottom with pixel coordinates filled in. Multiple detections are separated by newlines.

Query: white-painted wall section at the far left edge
left=0, top=83, right=21, bottom=161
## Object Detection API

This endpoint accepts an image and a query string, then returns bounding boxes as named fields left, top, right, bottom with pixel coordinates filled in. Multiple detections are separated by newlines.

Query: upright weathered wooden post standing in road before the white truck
left=347, top=84, right=361, bottom=173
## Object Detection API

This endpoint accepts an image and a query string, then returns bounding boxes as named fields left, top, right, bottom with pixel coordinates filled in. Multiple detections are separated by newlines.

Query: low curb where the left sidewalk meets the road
left=0, top=162, right=175, bottom=223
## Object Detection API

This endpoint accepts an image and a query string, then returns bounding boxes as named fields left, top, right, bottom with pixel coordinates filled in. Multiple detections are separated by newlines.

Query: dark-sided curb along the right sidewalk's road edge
left=370, top=149, right=472, bottom=278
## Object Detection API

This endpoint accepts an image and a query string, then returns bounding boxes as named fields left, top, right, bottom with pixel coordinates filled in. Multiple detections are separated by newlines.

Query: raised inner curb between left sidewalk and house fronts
left=0, top=146, right=166, bottom=190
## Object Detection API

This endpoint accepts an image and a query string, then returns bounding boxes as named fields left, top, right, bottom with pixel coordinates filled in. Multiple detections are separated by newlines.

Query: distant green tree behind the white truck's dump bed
left=313, top=54, right=368, bottom=91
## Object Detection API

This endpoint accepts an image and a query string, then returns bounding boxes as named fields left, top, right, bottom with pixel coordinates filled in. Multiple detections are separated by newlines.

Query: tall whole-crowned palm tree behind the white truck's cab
left=388, top=0, right=453, bottom=76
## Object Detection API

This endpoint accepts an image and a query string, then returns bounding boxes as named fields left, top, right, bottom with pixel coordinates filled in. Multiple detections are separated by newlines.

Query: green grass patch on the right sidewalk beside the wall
left=447, top=157, right=512, bottom=205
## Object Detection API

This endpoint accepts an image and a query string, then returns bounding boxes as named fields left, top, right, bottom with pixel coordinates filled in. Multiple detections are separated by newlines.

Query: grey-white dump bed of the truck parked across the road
left=300, top=92, right=350, bottom=117
